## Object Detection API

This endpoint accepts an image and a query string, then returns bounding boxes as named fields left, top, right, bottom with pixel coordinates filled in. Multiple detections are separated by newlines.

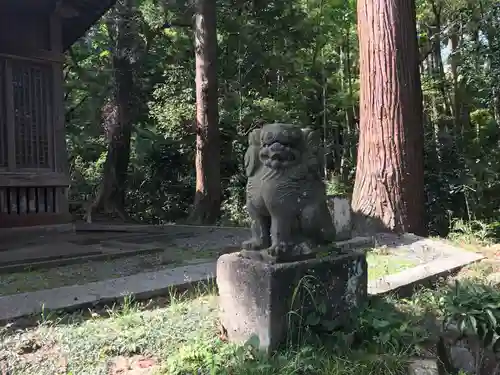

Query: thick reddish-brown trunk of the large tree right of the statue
left=352, top=0, right=426, bottom=234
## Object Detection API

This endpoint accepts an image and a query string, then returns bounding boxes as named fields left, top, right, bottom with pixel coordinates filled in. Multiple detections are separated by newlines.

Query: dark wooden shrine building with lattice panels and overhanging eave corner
left=0, top=0, right=115, bottom=228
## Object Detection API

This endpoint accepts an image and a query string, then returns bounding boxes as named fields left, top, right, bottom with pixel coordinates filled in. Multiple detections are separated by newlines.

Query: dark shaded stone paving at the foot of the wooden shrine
left=0, top=224, right=249, bottom=272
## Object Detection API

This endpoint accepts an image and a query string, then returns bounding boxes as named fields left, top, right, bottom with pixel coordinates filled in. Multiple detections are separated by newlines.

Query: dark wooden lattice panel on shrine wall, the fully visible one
left=12, top=60, right=52, bottom=168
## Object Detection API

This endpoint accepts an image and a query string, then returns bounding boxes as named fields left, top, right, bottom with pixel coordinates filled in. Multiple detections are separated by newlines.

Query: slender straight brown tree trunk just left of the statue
left=189, top=0, right=221, bottom=224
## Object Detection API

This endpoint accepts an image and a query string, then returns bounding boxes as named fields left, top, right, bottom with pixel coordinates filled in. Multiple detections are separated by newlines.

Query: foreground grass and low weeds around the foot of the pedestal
left=4, top=272, right=498, bottom=375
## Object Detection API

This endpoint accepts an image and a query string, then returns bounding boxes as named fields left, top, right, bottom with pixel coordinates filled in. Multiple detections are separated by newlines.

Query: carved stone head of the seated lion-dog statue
left=259, top=123, right=305, bottom=169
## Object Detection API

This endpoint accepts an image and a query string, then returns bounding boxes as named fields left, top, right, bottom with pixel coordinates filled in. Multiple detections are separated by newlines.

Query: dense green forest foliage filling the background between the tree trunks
left=65, top=0, right=500, bottom=235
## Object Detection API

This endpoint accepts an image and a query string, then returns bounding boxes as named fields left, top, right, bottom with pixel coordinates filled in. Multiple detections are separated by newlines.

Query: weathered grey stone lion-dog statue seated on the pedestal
left=242, top=123, right=335, bottom=262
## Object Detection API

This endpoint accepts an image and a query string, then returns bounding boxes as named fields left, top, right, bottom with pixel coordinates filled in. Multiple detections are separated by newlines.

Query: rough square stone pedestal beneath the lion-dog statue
left=217, top=251, right=368, bottom=352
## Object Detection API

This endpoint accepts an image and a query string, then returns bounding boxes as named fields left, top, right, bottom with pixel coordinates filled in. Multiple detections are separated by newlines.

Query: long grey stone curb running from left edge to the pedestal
left=0, top=263, right=215, bottom=321
